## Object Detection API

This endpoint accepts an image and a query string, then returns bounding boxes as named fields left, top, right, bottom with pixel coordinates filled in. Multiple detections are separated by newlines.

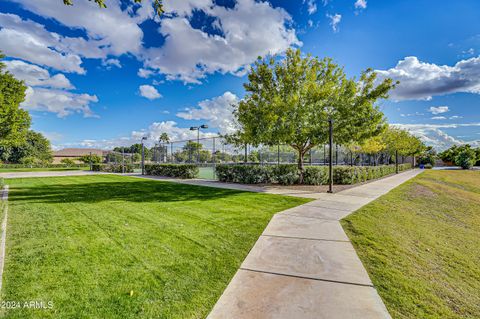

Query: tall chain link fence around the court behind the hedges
left=147, top=136, right=408, bottom=179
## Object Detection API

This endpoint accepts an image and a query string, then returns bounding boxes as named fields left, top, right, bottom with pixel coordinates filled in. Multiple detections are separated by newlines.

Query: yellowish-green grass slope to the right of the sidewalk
left=342, top=171, right=480, bottom=318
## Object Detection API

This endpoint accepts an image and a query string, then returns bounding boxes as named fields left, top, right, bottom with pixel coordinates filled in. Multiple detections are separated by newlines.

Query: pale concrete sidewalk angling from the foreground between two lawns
left=208, top=170, right=421, bottom=319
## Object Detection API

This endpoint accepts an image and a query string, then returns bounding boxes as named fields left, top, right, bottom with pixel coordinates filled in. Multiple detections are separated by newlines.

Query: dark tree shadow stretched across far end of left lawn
left=9, top=180, right=245, bottom=203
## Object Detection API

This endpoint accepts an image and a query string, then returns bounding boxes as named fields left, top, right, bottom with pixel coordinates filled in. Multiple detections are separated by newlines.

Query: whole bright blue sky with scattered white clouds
left=0, top=0, right=480, bottom=149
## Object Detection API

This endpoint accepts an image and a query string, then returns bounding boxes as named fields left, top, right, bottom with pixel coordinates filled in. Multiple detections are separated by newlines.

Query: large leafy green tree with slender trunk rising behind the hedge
left=235, top=49, right=394, bottom=180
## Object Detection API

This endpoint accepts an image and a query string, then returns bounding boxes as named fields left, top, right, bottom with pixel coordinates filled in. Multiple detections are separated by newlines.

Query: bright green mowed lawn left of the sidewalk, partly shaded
left=2, top=175, right=308, bottom=318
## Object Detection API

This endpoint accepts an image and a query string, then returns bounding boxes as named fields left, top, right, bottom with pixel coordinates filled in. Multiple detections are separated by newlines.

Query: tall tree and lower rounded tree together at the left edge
left=0, top=52, right=53, bottom=164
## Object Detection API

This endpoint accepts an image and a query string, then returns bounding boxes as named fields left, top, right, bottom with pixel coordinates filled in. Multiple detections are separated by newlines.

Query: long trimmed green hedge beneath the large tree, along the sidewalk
left=215, top=164, right=412, bottom=185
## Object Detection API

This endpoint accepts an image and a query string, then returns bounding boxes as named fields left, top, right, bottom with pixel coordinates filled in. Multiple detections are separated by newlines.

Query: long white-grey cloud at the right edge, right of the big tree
left=376, top=56, right=480, bottom=100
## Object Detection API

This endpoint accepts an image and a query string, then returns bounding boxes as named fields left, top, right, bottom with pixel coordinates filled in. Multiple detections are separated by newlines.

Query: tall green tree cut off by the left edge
left=0, top=52, right=31, bottom=160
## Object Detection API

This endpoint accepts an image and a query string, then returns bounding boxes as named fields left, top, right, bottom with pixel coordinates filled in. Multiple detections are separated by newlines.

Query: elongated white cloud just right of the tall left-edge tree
left=21, top=87, right=98, bottom=117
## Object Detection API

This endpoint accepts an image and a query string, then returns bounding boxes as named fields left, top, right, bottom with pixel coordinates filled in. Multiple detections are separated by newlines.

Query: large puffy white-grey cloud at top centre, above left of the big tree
left=144, top=0, right=301, bottom=83
